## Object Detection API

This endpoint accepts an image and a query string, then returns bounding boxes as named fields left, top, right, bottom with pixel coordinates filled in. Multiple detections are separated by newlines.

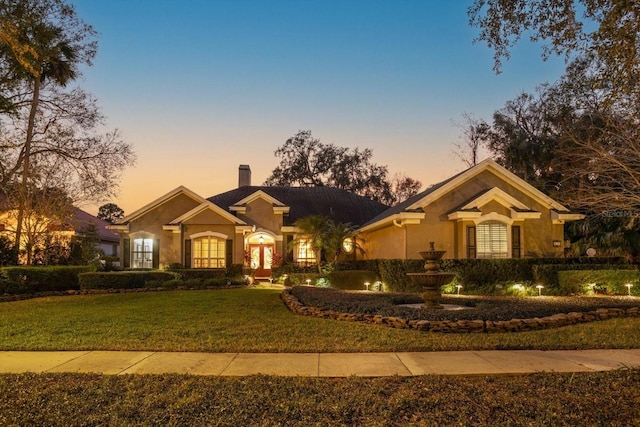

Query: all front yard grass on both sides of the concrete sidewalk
left=0, top=289, right=640, bottom=426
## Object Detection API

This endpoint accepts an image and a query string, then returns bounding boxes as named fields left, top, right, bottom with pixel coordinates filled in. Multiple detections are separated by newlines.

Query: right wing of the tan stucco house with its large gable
left=360, top=159, right=584, bottom=259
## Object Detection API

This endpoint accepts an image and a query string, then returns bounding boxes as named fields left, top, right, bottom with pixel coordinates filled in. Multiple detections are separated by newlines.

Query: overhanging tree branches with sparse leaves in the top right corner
left=467, top=0, right=640, bottom=108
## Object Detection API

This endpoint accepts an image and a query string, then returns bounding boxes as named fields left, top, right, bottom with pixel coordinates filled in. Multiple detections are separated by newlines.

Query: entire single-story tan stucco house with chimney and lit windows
left=109, top=160, right=581, bottom=278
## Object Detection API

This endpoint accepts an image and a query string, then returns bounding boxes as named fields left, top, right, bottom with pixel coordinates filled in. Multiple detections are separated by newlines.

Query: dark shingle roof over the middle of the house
left=208, top=186, right=389, bottom=226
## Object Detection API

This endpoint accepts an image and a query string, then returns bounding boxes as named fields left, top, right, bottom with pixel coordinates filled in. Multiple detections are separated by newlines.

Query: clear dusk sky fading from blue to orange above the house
left=71, top=0, right=564, bottom=213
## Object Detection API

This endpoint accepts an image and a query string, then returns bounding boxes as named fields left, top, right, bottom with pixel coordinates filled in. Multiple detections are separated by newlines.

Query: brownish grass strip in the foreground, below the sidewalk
left=0, top=370, right=640, bottom=426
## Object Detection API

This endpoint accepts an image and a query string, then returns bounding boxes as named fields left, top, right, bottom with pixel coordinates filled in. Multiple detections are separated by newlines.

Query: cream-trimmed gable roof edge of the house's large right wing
left=362, top=159, right=569, bottom=229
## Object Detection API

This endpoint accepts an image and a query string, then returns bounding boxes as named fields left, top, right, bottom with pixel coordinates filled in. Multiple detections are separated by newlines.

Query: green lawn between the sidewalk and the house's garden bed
left=0, top=289, right=640, bottom=352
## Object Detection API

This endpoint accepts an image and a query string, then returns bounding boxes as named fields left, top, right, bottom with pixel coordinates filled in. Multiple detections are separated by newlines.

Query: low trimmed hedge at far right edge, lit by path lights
left=558, top=270, right=640, bottom=295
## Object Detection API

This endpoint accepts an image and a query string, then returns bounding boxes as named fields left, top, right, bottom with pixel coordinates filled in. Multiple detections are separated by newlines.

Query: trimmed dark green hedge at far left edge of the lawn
left=0, top=266, right=95, bottom=294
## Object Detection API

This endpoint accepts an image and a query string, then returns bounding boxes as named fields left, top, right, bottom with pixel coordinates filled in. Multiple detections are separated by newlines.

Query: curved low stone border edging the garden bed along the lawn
left=280, top=289, right=640, bottom=333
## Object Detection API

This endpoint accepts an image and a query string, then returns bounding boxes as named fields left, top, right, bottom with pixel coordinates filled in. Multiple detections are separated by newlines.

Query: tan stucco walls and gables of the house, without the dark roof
left=114, top=161, right=580, bottom=267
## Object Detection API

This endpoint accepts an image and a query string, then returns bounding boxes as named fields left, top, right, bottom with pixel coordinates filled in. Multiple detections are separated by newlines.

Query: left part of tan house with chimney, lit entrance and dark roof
left=109, top=165, right=388, bottom=278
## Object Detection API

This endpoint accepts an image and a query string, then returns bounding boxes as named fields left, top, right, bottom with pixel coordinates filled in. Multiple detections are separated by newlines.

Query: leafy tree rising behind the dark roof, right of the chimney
left=265, top=130, right=421, bottom=205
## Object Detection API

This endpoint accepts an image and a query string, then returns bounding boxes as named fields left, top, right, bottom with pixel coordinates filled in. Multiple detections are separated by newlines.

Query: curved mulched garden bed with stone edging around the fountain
left=282, top=286, right=640, bottom=333
